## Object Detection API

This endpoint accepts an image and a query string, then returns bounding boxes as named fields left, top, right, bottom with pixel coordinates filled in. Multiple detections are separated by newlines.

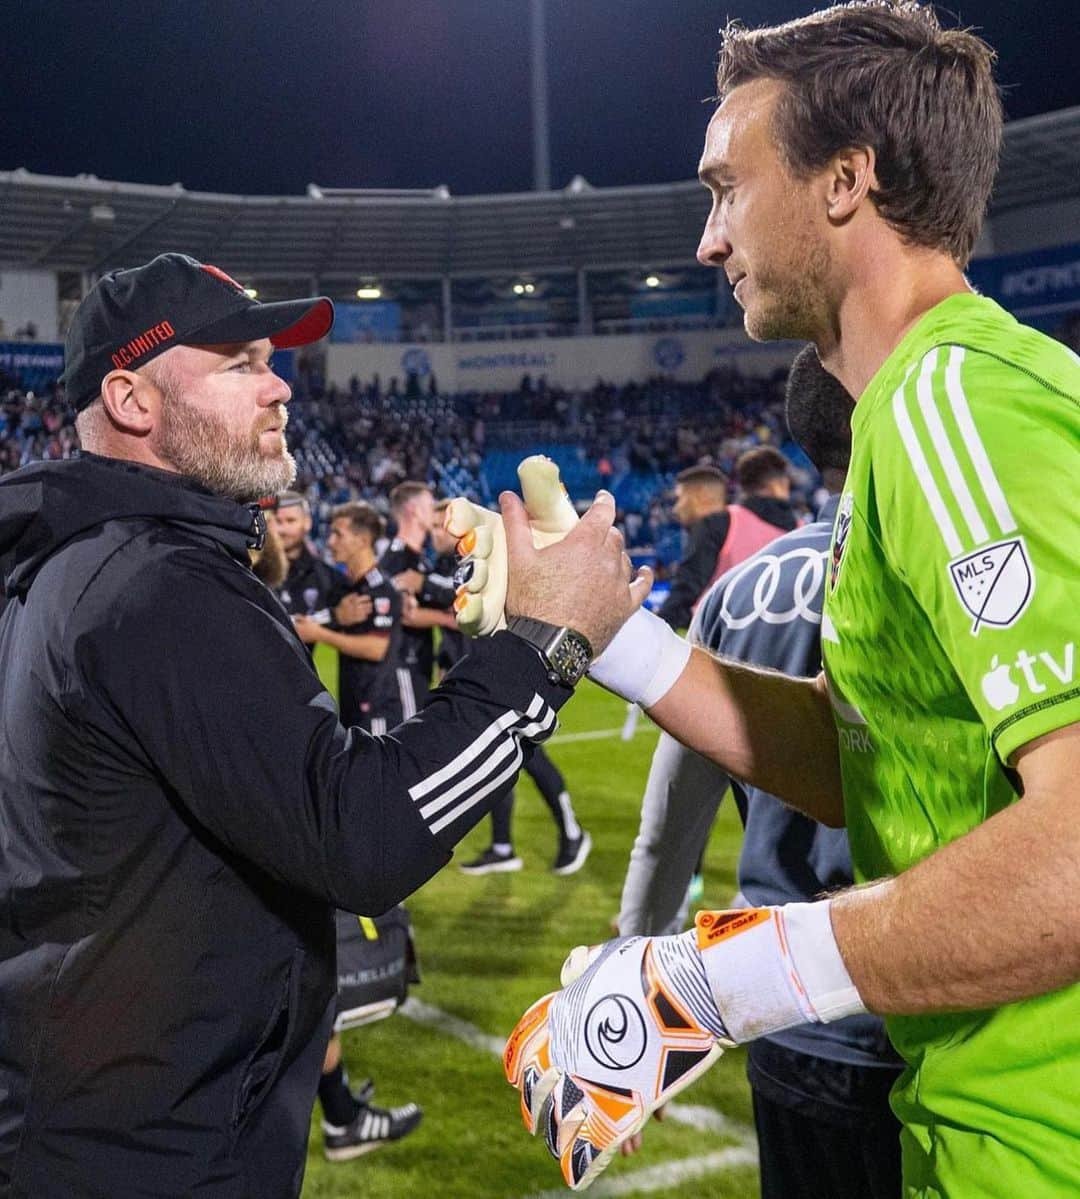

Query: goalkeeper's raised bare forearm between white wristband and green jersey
left=648, top=647, right=844, bottom=826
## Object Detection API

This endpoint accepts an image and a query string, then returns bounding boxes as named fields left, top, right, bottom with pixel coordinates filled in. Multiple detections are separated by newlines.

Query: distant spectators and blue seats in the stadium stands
left=0, top=357, right=813, bottom=559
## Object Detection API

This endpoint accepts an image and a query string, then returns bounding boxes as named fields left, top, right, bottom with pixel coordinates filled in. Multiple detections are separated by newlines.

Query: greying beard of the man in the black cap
left=158, top=396, right=296, bottom=504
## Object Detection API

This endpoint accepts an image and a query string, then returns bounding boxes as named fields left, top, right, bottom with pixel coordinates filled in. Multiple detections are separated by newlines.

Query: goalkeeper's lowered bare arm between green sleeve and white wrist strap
left=832, top=724, right=1080, bottom=1014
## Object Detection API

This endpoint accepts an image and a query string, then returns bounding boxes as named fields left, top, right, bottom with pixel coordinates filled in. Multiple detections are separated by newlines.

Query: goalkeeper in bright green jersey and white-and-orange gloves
left=502, top=0, right=1080, bottom=1199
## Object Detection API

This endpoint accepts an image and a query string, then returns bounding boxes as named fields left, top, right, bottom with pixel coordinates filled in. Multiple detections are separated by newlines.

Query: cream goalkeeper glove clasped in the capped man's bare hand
left=444, top=454, right=578, bottom=637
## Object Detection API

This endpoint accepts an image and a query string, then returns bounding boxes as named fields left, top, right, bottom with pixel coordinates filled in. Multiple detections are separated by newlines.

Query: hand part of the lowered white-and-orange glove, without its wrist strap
left=502, top=936, right=734, bottom=1191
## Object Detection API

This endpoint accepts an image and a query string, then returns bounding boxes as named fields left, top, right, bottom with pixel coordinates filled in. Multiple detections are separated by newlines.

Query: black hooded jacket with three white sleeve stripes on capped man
left=0, top=454, right=567, bottom=1199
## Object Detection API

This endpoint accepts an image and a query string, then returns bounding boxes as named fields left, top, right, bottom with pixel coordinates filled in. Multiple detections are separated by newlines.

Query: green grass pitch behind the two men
left=303, top=661, right=758, bottom=1199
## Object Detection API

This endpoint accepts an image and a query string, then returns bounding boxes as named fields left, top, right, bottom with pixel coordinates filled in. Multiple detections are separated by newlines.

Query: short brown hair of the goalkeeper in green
left=717, top=0, right=1002, bottom=267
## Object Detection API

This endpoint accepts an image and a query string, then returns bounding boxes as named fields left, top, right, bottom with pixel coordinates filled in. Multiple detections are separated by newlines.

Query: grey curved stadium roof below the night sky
left=0, top=108, right=1080, bottom=287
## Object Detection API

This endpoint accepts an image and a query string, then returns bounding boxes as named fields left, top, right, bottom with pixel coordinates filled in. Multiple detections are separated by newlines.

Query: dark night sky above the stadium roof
left=8, top=0, right=1080, bottom=195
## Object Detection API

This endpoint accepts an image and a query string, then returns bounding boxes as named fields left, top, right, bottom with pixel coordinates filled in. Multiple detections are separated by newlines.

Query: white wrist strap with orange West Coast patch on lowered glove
left=683, top=899, right=865, bottom=1043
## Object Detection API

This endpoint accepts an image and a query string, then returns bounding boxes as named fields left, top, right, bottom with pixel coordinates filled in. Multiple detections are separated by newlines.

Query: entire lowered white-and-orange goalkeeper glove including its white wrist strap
left=502, top=900, right=865, bottom=1191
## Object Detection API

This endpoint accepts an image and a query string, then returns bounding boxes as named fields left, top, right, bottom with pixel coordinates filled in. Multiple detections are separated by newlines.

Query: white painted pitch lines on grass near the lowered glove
left=398, top=995, right=758, bottom=1199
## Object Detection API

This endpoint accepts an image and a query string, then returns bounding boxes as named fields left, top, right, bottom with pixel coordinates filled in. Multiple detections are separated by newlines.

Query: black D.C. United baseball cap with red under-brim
left=60, top=254, right=333, bottom=411
